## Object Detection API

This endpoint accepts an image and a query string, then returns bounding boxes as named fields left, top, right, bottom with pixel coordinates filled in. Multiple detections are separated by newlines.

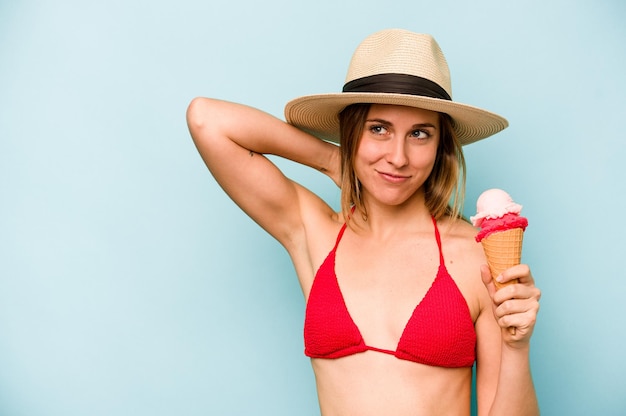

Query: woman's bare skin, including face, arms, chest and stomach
left=187, top=98, right=540, bottom=416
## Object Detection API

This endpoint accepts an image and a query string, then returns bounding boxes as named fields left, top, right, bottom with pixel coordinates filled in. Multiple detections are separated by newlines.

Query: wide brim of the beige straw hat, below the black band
left=285, top=92, right=509, bottom=145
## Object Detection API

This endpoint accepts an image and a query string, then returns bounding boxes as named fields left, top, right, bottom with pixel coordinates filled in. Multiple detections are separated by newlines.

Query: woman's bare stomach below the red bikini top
left=311, top=351, right=472, bottom=416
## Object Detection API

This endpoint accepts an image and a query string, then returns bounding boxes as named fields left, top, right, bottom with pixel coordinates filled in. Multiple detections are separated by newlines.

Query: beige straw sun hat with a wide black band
left=285, top=29, right=508, bottom=145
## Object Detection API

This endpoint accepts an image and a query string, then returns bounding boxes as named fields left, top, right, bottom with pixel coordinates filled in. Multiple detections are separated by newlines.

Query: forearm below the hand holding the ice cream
left=489, top=343, right=539, bottom=416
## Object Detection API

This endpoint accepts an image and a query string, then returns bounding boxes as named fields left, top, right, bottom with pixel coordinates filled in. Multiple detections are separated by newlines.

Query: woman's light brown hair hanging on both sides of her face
left=339, top=104, right=465, bottom=221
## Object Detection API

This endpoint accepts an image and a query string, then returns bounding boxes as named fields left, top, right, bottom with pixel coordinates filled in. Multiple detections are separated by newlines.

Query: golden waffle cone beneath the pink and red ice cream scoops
left=480, top=228, right=524, bottom=289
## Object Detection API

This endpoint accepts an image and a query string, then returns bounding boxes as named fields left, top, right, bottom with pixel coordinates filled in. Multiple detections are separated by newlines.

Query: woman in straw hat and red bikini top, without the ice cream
left=187, top=30, right=540, bottom=416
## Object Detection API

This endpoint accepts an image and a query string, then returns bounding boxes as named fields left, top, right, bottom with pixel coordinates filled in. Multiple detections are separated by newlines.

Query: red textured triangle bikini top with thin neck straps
left=304, top=218, right=476, bottom=367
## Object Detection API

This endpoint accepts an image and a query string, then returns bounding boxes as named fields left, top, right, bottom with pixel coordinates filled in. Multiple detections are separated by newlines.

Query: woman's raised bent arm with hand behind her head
left=187, top=98, right=340, bottom=246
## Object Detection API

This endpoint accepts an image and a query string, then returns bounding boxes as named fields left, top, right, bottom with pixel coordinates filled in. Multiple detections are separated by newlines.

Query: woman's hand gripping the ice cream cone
left=481, top=264, right=541, bottom=346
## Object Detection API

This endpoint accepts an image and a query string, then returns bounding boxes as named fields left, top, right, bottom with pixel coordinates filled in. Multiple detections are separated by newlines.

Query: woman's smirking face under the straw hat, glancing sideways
left=354, top=104, right=440, bottom=205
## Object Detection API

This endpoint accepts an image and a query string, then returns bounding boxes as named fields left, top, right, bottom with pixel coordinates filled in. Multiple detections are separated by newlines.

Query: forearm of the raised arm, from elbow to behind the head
left=187, top=98, right=339, bottom=180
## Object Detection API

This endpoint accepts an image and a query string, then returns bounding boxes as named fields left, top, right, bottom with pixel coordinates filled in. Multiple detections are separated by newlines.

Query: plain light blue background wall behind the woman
left=0, top=0, right=626, bottom=416
